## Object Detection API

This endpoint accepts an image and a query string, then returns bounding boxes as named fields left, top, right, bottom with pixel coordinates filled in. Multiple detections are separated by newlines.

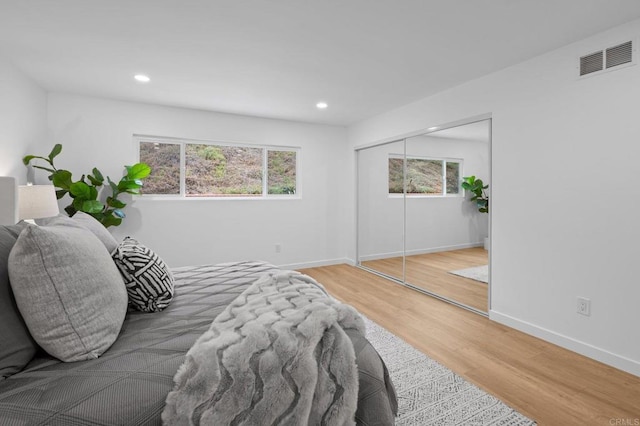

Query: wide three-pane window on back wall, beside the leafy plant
left=137, top=137, right=299, bottom=198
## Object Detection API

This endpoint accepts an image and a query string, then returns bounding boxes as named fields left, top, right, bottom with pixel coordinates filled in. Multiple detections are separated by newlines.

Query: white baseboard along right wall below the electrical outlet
left=489, top=310, right=640, bottom=377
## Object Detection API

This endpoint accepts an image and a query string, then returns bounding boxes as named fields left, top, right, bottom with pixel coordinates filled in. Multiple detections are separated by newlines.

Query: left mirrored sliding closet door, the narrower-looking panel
left=357, top=140, right=404, bottom=281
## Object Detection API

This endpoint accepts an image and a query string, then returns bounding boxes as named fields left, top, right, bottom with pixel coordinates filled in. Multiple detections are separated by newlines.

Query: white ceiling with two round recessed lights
left=0, top=0, right=640, bottom=125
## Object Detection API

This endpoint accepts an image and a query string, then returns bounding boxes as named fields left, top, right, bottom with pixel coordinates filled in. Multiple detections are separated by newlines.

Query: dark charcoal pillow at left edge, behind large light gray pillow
left=0, top=225, right=36, bottom=378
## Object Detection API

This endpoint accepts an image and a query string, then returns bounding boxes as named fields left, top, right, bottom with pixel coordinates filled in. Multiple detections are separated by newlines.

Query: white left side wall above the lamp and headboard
left=0, top=57, right=47, bottom=184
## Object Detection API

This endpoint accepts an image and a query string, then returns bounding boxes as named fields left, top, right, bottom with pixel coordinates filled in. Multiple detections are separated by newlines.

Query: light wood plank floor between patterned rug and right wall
left=301, top=265, right=640, bottom=426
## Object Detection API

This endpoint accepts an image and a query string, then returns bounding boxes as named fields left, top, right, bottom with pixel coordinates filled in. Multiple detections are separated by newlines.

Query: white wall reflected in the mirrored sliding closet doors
left=358, top=134, right=489, bottom=260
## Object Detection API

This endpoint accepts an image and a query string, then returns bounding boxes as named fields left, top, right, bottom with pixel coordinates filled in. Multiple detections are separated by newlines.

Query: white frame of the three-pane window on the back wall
left=133, top=135, right=302, bottom=201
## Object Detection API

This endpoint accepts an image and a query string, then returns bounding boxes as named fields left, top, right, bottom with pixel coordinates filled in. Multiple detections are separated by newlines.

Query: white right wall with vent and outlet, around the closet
left=349, top=21, right=640, bottom=375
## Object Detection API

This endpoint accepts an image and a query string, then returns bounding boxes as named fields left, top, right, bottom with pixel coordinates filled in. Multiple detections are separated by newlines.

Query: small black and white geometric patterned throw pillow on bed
left=111, top=237, right=174, bottom=312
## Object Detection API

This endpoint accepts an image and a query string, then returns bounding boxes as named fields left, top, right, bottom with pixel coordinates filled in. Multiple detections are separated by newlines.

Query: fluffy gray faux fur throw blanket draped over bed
left=162, top=271, right=365, bottom=426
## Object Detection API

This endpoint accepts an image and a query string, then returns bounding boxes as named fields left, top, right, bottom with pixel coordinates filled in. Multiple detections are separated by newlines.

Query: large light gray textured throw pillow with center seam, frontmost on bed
left=9, top=226, right=127, bottom=362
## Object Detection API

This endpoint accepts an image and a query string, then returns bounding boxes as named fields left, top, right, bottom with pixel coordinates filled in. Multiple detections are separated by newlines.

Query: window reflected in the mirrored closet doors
left=389, top=154, right=462, bottom=196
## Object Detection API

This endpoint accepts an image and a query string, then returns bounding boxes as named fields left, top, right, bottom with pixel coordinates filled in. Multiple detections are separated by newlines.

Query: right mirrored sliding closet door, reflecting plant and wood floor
left=405, top=120, right=490, bottom=312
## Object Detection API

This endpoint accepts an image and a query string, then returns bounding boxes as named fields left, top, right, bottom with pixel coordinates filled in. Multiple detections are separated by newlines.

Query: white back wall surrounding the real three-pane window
left=47, top=93, right=350, bottom=267
